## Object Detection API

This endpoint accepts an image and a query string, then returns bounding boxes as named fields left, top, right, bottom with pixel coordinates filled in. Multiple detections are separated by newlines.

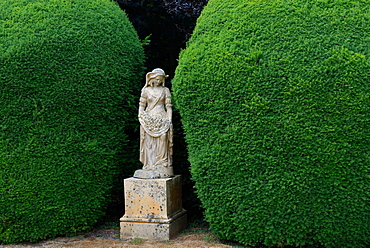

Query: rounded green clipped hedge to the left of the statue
left=0, top=0, right=144, bottom=243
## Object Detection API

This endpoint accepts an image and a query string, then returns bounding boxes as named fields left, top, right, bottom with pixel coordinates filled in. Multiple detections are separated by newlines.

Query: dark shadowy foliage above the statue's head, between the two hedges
left=116, top=0, right=208, bottom=77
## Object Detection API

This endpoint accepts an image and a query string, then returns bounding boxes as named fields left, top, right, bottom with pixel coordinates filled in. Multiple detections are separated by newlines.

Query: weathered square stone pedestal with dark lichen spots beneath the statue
left=120, top=175, right=187, bottom=240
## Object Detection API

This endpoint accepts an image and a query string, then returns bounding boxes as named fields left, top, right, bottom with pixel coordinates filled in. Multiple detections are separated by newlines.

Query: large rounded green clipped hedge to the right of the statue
left=173, top=0, right=370, bottom=247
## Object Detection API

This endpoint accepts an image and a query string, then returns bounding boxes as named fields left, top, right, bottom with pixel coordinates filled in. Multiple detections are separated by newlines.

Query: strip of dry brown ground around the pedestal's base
left=0, top=227, right=235, bottom=248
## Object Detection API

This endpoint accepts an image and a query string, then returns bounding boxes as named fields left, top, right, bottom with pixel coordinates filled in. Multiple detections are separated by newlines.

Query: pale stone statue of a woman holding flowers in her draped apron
left=134, top=68, right=174, bottom=178
